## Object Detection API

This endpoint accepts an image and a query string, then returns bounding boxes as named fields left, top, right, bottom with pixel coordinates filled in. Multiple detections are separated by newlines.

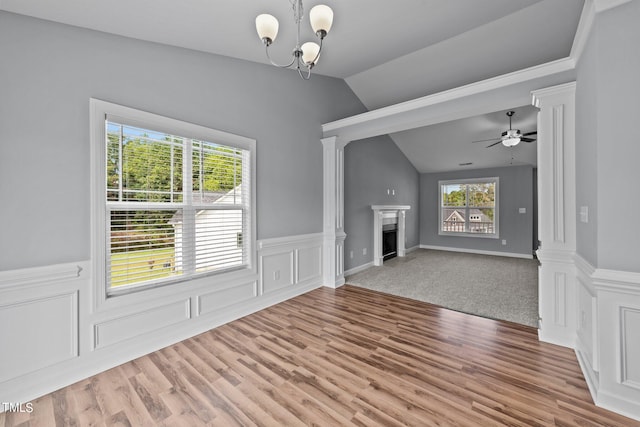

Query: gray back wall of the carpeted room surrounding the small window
left=420, top=166, right=533, bottom=255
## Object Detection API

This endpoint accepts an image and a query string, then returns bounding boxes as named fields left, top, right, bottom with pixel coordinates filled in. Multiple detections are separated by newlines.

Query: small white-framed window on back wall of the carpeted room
left=438, top=178, right=498, bottom=238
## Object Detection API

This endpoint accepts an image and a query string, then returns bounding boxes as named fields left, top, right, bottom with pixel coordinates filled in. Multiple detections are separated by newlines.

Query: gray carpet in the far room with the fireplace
left=346, top=249, right=538, bottom=328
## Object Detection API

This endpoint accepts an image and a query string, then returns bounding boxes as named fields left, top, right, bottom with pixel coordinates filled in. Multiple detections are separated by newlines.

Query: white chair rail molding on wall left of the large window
left=0, top=261, right=88, bottom=290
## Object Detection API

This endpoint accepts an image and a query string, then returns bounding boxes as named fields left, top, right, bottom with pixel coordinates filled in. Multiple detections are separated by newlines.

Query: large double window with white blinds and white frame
left=92, top=100, right=255, bottom=295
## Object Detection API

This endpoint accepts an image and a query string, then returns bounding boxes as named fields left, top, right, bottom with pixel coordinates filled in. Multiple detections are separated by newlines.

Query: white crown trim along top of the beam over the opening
left=322, top=57, right=575, bottom=136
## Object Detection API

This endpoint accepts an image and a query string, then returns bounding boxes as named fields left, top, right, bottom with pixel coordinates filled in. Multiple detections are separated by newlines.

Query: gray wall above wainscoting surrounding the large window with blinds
left=0, top=12, right=365, bottom=270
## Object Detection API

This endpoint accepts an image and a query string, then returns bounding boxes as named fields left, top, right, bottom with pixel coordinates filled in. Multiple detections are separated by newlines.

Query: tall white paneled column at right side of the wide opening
left=532, top=82, right=577, bottom=348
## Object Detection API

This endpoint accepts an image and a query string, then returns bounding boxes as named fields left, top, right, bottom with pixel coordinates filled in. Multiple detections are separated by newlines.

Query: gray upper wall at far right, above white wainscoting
left=576, top=1, right=640, bottom=272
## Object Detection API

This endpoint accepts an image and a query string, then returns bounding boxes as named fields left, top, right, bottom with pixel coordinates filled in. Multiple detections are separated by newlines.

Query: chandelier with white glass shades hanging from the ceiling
left=256, top=0, right=333, bottom=80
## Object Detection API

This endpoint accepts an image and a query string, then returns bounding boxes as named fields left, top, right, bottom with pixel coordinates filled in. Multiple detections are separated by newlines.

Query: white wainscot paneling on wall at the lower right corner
left=575, top=255, right=640, bottom=420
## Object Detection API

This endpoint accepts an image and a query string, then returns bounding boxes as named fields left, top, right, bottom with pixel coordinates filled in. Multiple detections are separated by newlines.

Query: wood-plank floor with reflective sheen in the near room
left=0, top=285, right=640, bottom=426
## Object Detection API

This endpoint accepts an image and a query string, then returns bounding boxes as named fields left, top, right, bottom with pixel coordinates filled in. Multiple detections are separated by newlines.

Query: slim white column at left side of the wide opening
left=322, top=136, right=348, bottom=288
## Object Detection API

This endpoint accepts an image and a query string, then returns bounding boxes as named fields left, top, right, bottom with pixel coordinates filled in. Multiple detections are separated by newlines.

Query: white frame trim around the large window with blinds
left=90, top=98, right=257, bottom=309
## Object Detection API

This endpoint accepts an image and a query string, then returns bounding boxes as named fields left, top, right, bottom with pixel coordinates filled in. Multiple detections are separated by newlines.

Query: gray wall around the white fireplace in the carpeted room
left=344, top=135, right=419, bottom=270
